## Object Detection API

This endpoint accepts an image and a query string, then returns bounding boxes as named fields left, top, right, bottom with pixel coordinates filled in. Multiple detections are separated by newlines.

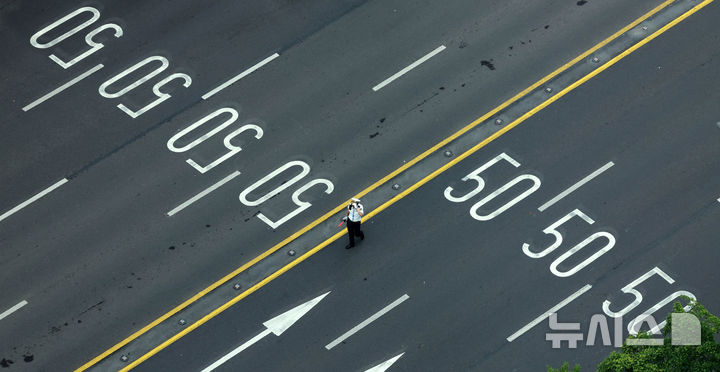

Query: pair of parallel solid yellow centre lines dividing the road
left=75, top=0, right=714, bottom=372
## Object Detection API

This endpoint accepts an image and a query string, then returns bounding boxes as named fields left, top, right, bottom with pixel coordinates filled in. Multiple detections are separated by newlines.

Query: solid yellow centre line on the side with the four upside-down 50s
left=75, top=0, right=674, bottom=372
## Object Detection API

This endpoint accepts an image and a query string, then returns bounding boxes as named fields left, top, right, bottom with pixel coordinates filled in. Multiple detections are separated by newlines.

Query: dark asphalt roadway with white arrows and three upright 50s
left=138, top=4, right=720, bottom=370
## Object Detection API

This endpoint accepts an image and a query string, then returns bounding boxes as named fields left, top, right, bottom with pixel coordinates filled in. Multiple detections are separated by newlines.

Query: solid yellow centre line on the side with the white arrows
left=121, top=0, right=714, bottom=372
